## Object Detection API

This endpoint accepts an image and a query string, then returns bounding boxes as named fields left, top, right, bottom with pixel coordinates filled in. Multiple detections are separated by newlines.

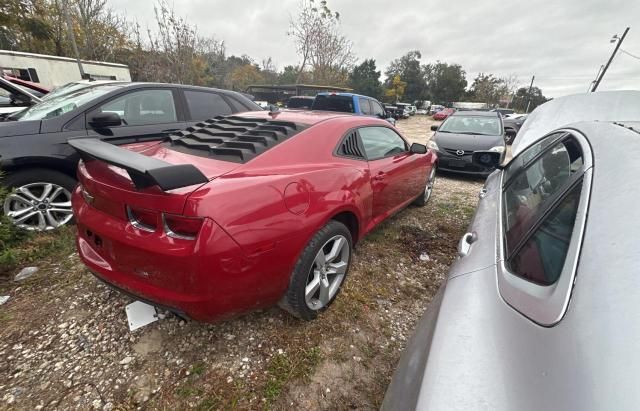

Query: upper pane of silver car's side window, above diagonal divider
left=504, top=139, right=582, bottom=255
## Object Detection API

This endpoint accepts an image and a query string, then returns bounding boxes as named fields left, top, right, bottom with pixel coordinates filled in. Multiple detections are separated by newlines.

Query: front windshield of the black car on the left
left=11, top=84, right=122, bottom=121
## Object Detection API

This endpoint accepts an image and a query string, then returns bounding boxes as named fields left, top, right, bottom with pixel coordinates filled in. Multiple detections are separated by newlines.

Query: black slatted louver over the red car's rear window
left=165, top=116, right=306, bottom=163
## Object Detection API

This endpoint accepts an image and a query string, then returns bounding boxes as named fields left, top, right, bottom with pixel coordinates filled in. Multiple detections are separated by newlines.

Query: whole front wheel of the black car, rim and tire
left=2, top=169, right=76, bottom=231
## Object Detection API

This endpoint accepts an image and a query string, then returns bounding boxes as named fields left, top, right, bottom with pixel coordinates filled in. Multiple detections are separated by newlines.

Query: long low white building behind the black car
left=0, top=50, right=131, bottom=88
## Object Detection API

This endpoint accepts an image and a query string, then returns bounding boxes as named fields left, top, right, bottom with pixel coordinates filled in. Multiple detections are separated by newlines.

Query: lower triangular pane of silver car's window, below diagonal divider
left=510, top=183, right=582, bottom=285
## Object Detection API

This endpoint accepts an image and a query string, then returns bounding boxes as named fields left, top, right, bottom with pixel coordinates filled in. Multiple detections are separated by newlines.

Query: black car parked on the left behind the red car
left=0, top=82, right=259, bottom=231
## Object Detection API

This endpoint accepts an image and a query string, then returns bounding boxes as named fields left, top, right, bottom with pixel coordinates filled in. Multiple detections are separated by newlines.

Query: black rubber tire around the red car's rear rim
left=278, top=220, right=353, bottom=321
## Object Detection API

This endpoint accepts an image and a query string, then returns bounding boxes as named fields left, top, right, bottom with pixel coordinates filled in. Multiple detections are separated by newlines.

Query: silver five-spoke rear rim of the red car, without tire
left=304, top=235, right=351, bottom=310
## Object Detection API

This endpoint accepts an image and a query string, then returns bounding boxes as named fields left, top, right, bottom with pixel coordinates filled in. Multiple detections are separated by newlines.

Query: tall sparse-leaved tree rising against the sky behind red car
left=287, top=0, right=355, bottom=85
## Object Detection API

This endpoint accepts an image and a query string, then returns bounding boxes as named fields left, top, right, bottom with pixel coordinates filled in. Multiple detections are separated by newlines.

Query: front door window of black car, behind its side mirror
left=98, top=90, right=178, bottom=126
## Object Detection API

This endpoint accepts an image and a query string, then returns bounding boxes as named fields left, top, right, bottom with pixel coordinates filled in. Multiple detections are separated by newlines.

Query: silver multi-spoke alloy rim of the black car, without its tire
left=4, top=182, right=73, bottom=231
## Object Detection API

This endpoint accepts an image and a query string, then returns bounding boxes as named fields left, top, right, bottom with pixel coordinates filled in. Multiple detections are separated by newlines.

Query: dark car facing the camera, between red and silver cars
left=427, top=111, right=506, bottom=176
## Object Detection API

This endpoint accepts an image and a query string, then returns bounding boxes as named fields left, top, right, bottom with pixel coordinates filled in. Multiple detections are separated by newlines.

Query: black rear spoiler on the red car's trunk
left=68, top=138, right=209, bottom=191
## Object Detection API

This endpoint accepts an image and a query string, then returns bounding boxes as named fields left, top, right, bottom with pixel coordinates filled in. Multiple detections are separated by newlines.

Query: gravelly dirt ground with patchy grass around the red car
left=0, top=116, right=482, bottom=410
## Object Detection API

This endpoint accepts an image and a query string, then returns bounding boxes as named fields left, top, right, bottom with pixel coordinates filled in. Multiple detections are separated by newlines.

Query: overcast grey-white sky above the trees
left=110, top=0, right=640, bottom=97
